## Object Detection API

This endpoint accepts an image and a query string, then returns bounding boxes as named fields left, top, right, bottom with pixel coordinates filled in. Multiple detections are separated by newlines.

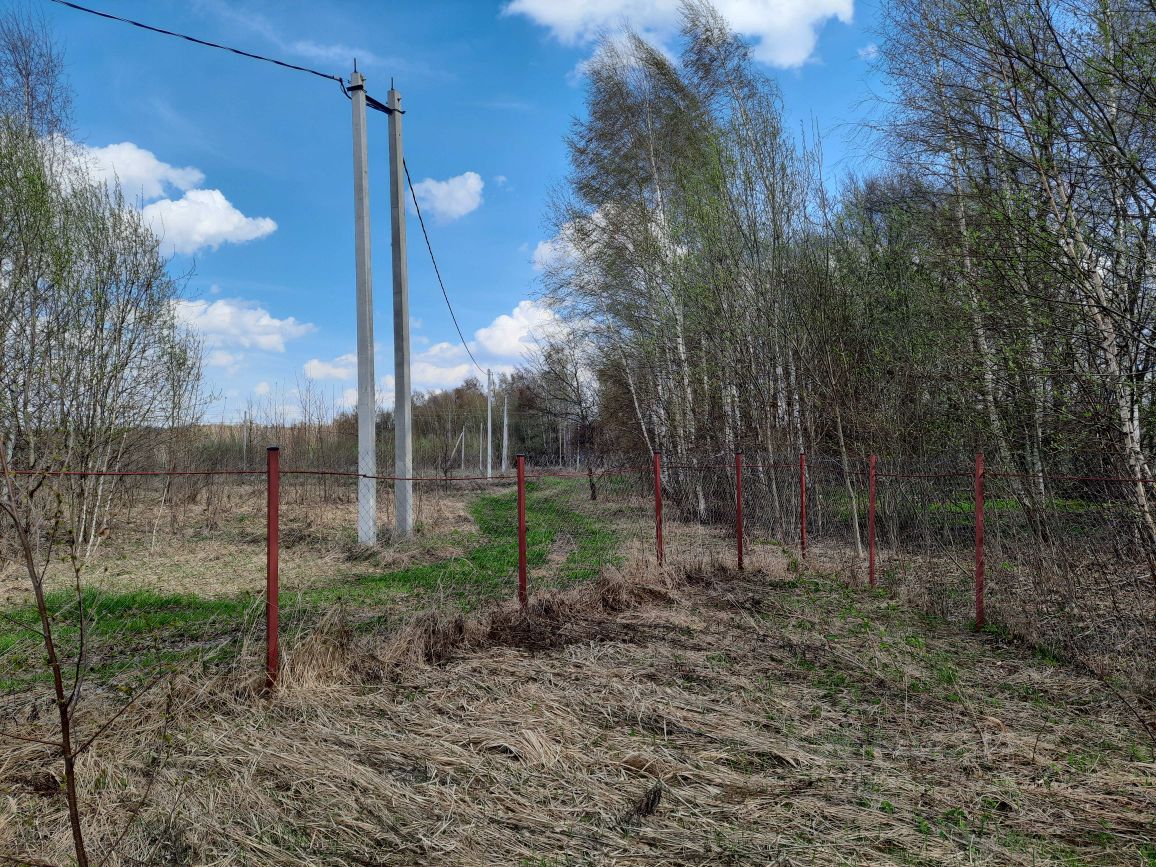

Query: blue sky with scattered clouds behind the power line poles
left=44, top=0, right=880, bottom=417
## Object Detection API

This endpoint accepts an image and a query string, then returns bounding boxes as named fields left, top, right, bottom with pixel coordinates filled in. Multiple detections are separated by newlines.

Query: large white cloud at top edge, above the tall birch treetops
left=502, top=0, right=854, bottom=67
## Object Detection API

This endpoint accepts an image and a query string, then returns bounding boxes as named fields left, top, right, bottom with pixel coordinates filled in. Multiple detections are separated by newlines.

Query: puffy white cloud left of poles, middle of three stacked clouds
left=141, top=190, right=277, bottom=255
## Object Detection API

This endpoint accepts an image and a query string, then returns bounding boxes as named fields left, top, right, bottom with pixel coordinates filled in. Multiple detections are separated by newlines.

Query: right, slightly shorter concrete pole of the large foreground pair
left=386, top=87, right=414, bottom=538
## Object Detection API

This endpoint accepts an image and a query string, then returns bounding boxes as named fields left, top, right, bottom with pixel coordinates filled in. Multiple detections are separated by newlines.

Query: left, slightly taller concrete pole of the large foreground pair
left=349, top=69, right=377, bottom=544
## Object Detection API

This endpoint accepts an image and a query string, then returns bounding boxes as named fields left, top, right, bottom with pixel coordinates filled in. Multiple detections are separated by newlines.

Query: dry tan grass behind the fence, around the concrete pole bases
left=0, top=483, right=492, bottom=607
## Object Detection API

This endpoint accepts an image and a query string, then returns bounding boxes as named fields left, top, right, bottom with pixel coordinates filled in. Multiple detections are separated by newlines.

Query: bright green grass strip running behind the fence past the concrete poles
left=0, top=479, right=618, bottom=690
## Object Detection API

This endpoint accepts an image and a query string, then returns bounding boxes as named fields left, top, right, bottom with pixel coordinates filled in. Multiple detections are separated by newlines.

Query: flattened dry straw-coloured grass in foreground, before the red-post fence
left=0, top=552, right=1156, bottom=865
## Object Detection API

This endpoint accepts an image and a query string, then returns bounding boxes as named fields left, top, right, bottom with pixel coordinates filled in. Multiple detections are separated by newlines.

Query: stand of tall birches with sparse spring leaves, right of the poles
left=529, top=0, right=1156, bottom=515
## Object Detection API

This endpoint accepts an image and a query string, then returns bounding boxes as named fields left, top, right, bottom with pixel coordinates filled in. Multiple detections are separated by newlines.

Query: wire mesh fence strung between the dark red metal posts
left=0, top=453, right=1156, bottom=694
